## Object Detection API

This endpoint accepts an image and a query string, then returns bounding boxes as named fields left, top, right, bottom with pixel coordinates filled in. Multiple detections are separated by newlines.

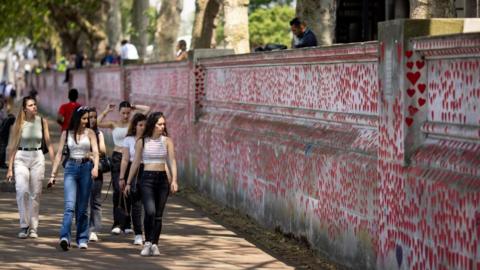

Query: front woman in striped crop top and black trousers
left=124, top=112, right=178, bottom=256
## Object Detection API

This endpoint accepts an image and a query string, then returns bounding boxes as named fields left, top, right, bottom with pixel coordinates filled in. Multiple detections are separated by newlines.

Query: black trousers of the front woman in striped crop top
left=140, top=171, right=170, bottom=244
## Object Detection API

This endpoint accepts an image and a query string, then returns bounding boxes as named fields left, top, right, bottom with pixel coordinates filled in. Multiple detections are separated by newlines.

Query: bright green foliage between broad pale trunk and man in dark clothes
left=249, top=5, right=295, bottom=47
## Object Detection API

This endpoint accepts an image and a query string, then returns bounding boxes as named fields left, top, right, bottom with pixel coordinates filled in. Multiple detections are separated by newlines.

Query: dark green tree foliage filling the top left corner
left=0, top=0, right=106, bottom=57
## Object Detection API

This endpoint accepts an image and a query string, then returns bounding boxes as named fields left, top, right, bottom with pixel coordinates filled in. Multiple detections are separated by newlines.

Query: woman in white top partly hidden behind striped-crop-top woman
left=120, top=113, right=147, bottom=245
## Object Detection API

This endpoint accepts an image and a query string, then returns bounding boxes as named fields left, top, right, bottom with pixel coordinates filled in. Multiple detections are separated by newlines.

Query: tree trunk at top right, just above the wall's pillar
left=410, top=0, right=457, bottom=19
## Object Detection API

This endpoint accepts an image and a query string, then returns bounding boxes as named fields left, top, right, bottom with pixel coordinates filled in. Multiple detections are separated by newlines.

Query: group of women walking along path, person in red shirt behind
left=7, top=89, right=178, bottom=256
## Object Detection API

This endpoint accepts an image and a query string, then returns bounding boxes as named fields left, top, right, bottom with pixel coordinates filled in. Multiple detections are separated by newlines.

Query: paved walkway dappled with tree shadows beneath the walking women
left=0, top=118, right=293, bottom=269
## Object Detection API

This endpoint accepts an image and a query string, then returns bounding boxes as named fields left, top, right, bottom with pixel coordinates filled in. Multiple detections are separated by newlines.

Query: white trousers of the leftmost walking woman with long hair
left=13, top=150, right=45, bottom=231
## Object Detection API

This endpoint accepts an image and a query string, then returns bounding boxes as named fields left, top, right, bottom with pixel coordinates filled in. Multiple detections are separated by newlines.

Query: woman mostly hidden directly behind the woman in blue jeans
left=88, top=107, right=107, bottom=242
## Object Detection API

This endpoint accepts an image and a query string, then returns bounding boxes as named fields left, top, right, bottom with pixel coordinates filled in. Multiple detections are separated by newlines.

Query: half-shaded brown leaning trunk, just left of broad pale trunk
left=190, top=0, right=220, bottom=49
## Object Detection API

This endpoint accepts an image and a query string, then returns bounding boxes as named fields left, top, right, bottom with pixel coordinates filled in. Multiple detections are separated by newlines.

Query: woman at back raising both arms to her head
left=98, top=101, right=150, bottom=235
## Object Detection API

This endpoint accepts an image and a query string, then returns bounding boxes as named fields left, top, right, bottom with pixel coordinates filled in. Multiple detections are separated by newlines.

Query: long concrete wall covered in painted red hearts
left=36, top=20, right=480, bottom=269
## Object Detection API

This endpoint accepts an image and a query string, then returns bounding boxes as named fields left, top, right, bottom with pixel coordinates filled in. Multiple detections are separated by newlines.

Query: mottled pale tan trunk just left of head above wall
left=155, top=0, right=183, bottom=61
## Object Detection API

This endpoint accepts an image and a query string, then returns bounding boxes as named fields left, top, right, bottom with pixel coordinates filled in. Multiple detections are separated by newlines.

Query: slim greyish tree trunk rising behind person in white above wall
left=131, top=0, right=148, bottom=59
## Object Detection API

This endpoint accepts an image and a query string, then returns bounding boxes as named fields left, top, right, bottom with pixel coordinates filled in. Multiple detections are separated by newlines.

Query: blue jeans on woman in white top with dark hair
left=60, top=161, right=93, bottom=244
